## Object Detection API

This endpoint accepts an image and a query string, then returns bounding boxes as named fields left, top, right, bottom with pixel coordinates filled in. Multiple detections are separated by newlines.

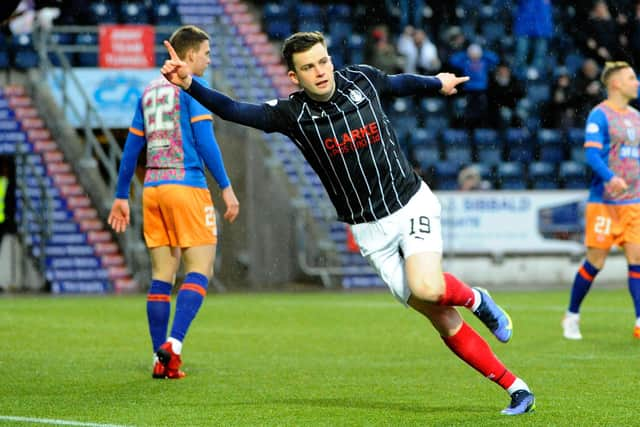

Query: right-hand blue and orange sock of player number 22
left=171, top=272, right=209, bottom=342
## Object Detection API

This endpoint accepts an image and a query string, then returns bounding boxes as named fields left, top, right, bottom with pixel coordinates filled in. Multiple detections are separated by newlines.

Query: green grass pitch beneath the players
left=0, top=287, right=640, bottom=426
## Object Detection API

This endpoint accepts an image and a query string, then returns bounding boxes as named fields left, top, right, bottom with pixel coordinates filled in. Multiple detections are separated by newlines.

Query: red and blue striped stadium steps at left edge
left=5, top=85, right=138, bottom=293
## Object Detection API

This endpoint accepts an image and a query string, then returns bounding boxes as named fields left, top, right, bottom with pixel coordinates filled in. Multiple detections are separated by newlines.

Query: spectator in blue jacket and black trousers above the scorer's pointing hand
left=449, top=43, right=499, bottom=128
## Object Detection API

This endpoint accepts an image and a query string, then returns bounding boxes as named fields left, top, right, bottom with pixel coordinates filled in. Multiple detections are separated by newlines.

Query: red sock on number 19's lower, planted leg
left=442, top=321, right=516, bottom=390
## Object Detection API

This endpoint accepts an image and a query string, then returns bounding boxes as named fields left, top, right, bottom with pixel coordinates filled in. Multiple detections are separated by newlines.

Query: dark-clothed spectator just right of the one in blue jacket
left=487, top=63, right=525, bottom=129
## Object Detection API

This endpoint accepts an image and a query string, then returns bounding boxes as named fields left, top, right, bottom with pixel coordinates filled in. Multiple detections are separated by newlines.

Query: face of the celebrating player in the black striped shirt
left=289, top=43, right=335, bottom=101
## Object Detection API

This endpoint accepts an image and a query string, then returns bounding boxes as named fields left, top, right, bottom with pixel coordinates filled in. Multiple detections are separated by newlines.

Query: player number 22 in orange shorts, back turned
left=109, top=26, right=239, bottom=379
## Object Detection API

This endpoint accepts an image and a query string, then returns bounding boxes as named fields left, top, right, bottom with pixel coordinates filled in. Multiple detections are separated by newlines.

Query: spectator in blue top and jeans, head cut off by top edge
left=513, top=0, right=553, bottom=77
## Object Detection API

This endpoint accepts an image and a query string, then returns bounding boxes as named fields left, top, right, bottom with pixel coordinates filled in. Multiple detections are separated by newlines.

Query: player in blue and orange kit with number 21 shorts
left=562, top=61, right=640, bottom=340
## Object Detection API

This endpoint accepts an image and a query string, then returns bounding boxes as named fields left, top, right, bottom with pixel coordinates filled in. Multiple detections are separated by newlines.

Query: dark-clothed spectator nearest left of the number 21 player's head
left=541, top=67, right=577, bottom=129
